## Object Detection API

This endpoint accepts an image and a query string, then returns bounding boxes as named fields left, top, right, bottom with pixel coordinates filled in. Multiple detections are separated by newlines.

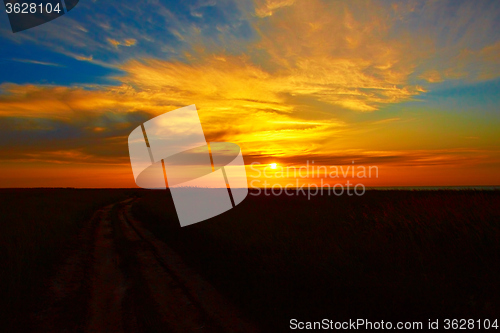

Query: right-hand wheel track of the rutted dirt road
left=118, top=201, right=259, bottom=332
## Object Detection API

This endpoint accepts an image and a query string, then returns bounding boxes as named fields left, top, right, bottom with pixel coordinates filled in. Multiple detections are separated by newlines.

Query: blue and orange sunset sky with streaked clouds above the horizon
left=0, top=0, right=500, bottom=187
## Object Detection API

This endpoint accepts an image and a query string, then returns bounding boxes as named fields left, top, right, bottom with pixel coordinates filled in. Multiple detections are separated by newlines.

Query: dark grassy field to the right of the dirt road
left=133, top=191, right=500, bottom=331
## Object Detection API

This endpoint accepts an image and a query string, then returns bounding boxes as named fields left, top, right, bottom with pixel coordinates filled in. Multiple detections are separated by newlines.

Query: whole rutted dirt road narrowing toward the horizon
left=34, top=199, right=259, bottom=332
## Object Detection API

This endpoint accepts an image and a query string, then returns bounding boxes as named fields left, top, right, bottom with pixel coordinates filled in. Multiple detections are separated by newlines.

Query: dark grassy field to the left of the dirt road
left=0, top=189, right=131, bottom=332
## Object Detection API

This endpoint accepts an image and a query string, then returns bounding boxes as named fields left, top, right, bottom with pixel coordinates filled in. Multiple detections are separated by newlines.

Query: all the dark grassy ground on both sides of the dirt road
left=0, top=189, right=500, bottom=332
